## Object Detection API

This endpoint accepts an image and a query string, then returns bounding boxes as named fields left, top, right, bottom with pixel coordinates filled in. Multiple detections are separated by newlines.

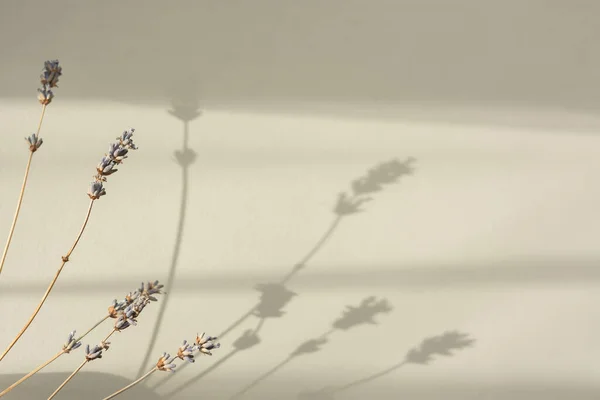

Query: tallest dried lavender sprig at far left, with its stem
left=0, top=60, right=62, bottom=282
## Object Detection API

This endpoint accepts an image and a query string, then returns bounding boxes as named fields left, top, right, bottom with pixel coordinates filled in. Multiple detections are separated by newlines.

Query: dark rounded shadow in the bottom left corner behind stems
left=0, top=371, right=161, bottom=400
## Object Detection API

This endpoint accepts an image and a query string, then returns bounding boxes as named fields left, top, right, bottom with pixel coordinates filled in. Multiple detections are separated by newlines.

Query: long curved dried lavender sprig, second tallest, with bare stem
left=0, top=129, right=137, bottom=361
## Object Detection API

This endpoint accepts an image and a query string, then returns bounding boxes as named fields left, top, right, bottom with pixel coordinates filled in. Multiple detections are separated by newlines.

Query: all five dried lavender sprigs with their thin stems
left=0, top=60, right=220, bottom=400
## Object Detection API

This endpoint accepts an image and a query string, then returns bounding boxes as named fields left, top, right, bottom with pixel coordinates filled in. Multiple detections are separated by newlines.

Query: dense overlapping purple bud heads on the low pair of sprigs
left=108, top=281, right=164, bottom=331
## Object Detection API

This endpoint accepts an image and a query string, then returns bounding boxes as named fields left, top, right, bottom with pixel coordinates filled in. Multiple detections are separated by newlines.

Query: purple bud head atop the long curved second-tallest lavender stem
left=88, top=128, right=138, bottom=200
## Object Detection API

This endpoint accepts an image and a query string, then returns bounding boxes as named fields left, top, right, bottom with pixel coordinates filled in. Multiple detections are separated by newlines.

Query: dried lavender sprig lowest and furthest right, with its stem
left=102, top=333, right=221, bottom=400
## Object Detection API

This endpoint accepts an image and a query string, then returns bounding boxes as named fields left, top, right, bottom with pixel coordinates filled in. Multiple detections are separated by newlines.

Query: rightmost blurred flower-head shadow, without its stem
left=405, top=331, right=475, bottom=365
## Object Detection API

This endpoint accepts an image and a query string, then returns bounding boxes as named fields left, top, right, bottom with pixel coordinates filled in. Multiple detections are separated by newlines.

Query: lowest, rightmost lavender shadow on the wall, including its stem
left=298, top=331, right=475, bottom=400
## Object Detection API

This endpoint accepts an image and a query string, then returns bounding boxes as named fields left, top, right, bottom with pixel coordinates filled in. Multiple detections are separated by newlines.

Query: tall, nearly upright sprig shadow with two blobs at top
left=138, top=90, right=201, bottom=376
